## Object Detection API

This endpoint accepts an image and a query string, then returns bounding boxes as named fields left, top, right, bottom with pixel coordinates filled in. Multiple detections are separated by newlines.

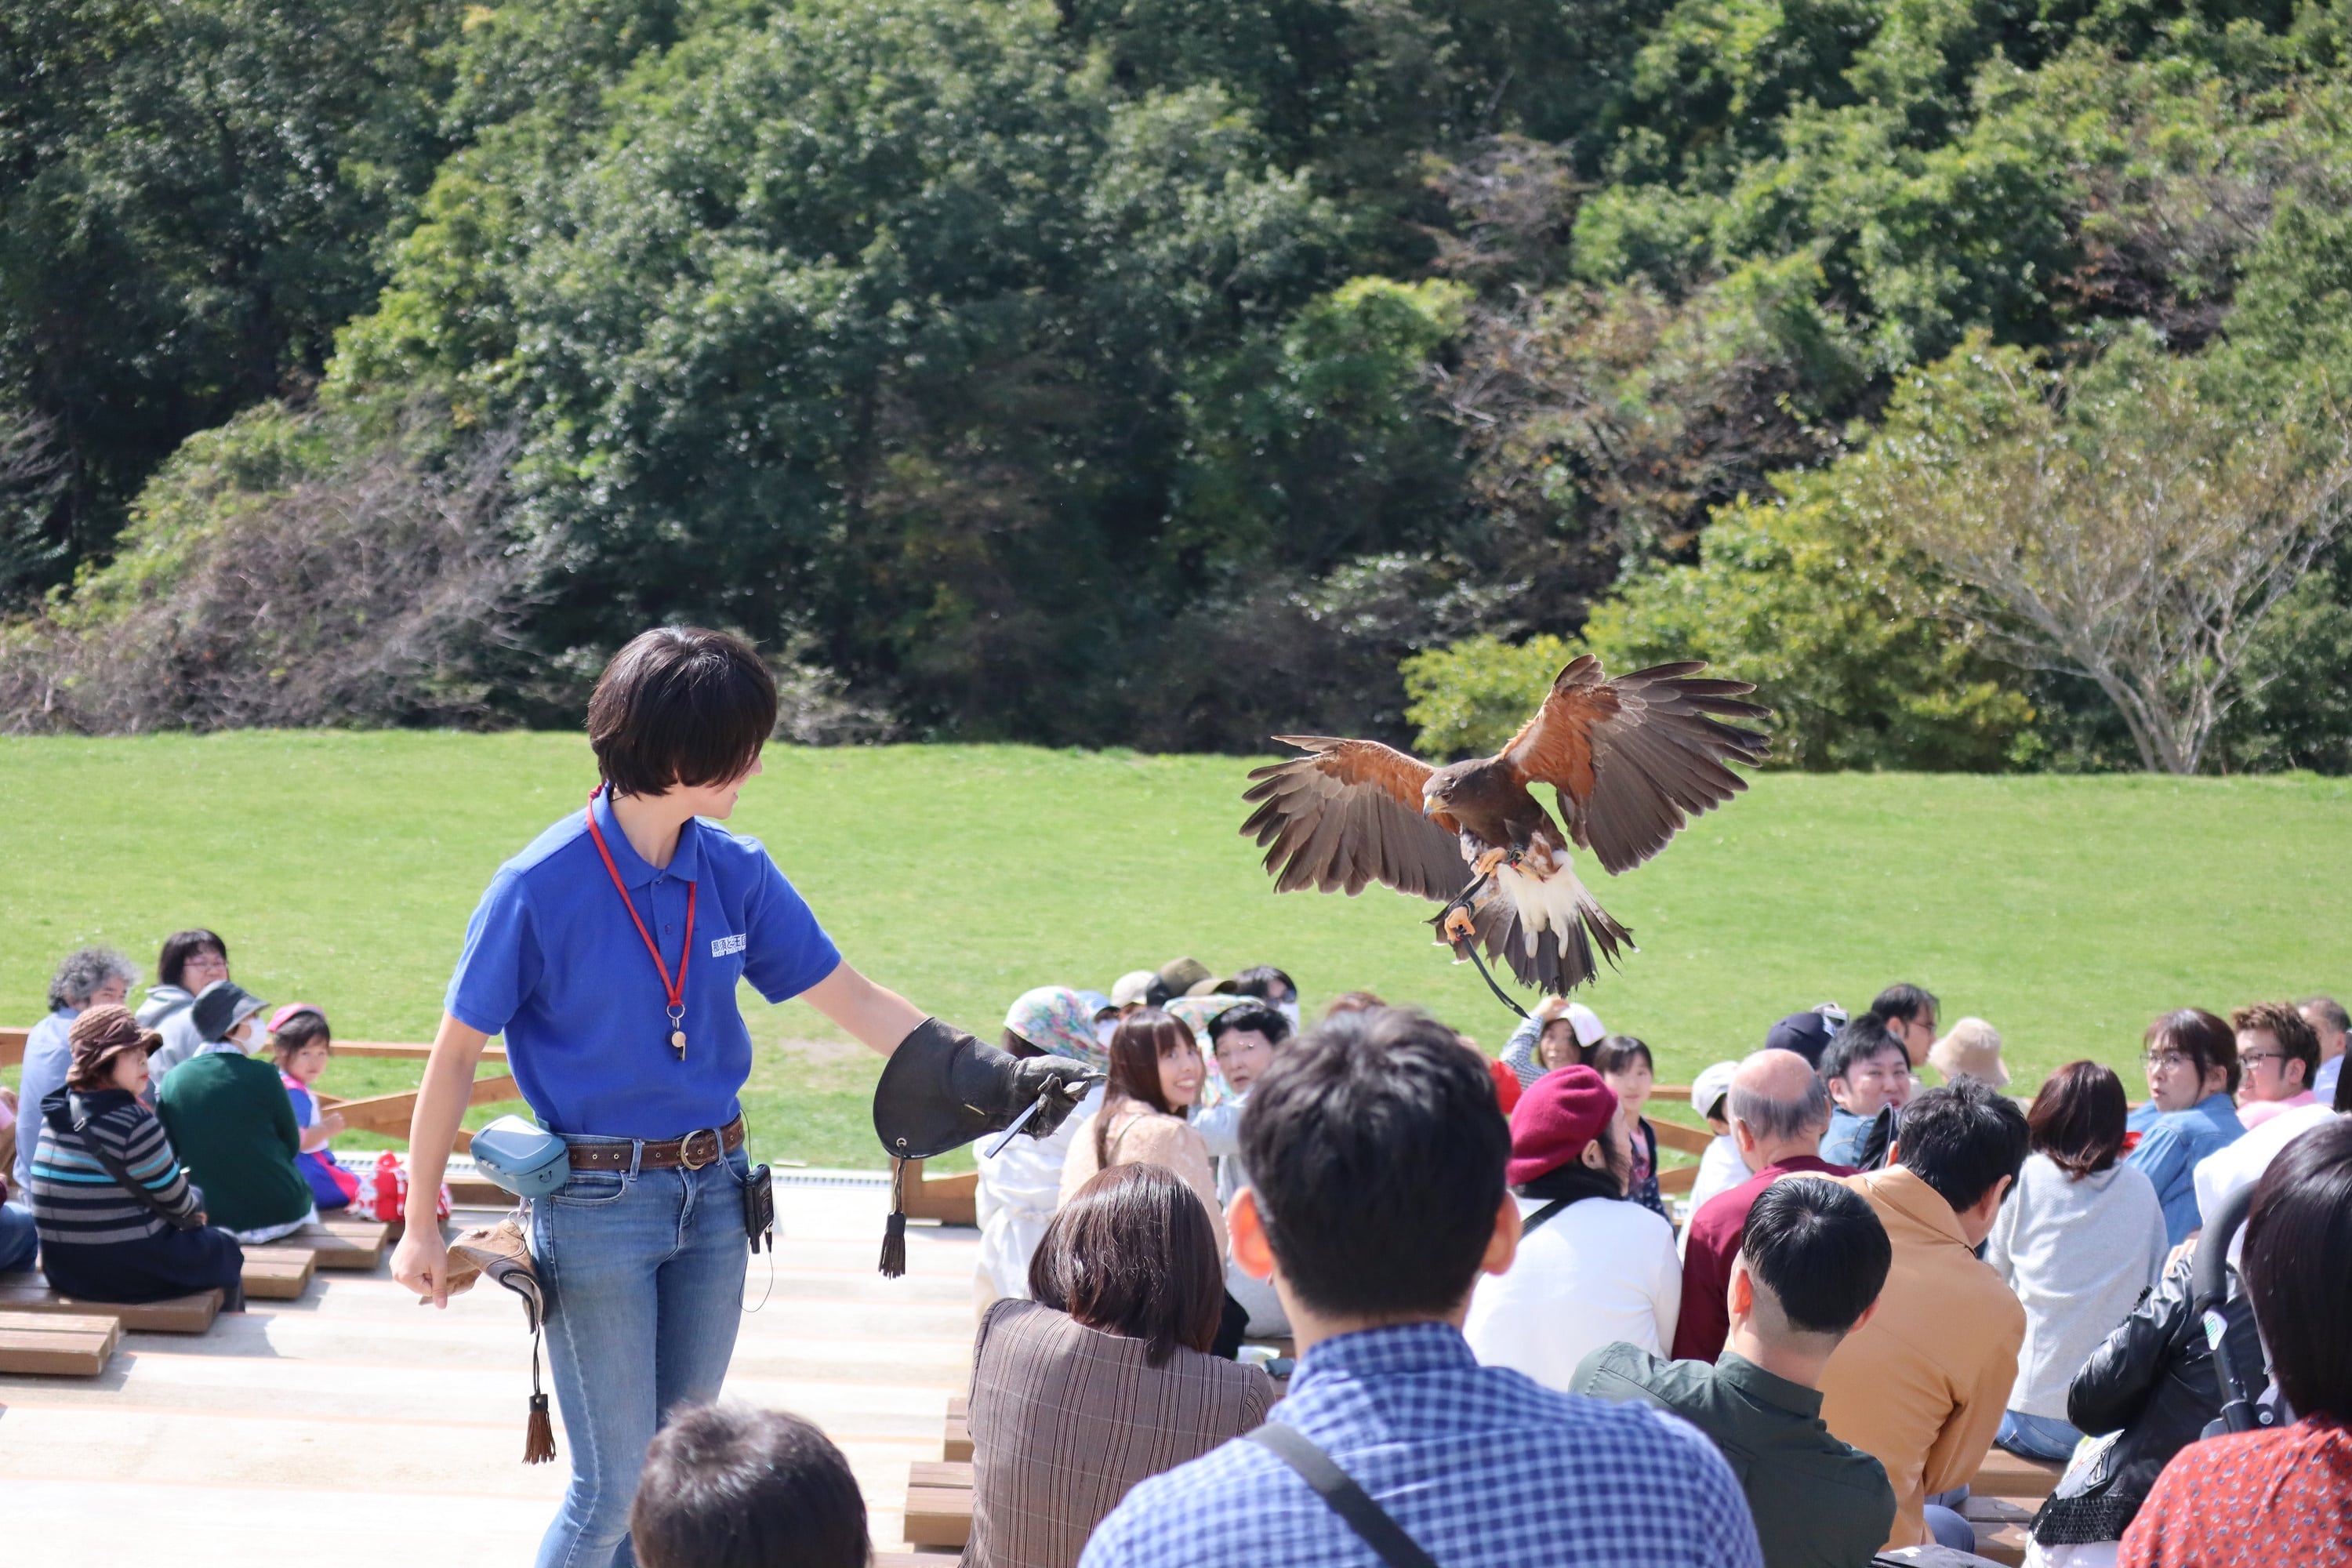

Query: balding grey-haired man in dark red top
left=1675, top=1051, right=1853, bottom=1363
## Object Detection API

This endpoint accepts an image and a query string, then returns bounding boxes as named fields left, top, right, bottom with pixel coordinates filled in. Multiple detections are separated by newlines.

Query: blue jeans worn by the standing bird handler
left=532, top=1138, right=750, bottom=1568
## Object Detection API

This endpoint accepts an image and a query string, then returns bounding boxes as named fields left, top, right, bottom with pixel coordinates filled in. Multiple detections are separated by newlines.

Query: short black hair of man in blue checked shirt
left=1242, top=1008, right=1510, bottom=1316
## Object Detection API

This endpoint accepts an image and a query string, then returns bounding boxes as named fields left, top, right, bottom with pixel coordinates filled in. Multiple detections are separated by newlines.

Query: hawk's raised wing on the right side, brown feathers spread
left=1503, top=654, right=1771, bottom=874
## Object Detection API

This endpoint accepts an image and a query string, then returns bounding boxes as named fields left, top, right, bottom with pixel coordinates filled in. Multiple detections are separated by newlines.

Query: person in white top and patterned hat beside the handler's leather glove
left=971, top=985, right=1108, bottom=1312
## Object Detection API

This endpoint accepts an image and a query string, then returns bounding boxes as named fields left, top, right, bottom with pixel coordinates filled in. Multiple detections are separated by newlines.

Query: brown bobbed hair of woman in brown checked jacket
left=1030, top=1166, right=1225, bottom=1366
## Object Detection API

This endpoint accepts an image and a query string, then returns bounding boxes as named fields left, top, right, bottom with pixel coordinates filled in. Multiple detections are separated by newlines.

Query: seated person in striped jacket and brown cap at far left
left=31, top=1006, right=245, bottom=1312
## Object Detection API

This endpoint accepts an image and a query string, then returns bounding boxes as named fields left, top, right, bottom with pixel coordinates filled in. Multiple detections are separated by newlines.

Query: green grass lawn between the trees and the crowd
left=0, top=734, right=2352, bottom=1166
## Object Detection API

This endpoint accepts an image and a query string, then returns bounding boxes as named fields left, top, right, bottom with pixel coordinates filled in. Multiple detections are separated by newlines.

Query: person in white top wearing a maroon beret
left=1463, top=1067, right=1682, bottom=1392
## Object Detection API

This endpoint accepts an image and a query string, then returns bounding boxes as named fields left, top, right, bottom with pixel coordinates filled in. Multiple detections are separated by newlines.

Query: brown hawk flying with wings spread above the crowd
left=1242, top=654, right=1771, bottom=994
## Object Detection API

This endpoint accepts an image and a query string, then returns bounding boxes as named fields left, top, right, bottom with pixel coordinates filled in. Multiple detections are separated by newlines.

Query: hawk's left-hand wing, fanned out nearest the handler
left=1242, top=736, right=1470, bottom=900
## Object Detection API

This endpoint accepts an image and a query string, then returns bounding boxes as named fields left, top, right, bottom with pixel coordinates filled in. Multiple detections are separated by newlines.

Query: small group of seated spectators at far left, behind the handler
left=0, top=928, right=360, bottom=1312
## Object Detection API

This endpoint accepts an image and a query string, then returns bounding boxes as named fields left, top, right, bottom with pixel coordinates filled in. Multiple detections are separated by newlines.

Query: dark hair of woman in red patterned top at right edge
left=2239, top=1116, right=2352, bottom=1422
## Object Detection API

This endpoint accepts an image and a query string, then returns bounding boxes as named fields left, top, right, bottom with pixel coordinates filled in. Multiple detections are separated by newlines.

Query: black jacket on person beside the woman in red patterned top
left=2032, top=1255, right=2263, bottom=1549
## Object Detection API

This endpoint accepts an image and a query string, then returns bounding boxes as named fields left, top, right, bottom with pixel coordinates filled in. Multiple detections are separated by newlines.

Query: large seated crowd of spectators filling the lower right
left=637, top=964, right=2352, bottom=1568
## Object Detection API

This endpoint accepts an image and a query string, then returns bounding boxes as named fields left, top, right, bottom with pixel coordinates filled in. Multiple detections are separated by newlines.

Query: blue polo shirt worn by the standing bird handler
left=445, top=794, right=842, bottom=1138
